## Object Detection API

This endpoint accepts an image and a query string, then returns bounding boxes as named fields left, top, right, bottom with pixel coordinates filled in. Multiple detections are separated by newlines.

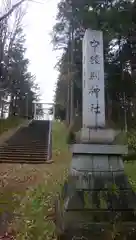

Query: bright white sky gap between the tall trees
left=24, top=0, right=59, bottom=103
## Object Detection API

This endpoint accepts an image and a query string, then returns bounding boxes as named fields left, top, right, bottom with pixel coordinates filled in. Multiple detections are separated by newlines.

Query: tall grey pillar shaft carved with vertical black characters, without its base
left=83, top=29, right=105, bottom=127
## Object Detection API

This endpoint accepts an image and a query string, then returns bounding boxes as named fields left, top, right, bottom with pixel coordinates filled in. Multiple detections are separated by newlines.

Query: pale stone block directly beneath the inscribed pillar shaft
left=79, top=128, right=120, bottom=144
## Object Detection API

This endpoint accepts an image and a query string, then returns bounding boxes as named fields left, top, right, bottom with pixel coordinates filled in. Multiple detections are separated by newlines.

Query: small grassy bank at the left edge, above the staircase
left=0, top=117, right=23, bottom=134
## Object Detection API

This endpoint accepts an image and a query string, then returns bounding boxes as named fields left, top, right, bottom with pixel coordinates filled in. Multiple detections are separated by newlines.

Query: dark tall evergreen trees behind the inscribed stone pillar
left=53, top=0, right=136, bottom=129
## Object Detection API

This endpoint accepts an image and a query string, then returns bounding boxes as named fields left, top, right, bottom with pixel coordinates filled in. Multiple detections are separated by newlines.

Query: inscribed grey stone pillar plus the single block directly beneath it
left=81, top=29, right=118, bottom=143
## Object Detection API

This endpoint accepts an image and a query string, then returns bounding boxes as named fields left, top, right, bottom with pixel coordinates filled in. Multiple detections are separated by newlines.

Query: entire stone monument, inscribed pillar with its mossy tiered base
left=54, top=29, right=136, bottom=239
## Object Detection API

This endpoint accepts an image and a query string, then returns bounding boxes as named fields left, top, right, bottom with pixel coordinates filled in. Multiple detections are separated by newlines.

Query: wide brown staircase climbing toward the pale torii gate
left=0, top=120, right=51, bottom=164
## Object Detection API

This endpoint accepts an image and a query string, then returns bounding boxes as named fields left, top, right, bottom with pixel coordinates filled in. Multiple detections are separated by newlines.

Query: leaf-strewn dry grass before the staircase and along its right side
left=0, top=123, right=70, bottom=240
